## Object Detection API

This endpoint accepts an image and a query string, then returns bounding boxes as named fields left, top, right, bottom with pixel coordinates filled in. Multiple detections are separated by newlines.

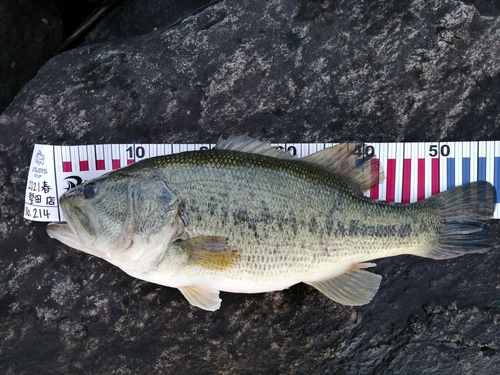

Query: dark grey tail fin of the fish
left=426, top=181, right=497, bottom=259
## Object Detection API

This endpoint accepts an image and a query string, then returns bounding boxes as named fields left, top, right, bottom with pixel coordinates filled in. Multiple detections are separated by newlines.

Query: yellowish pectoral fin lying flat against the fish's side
left=174, top=236, right=240, bottom=270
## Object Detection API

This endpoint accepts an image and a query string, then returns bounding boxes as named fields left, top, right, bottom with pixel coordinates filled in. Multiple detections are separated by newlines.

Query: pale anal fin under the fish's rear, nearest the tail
left=307, top=263, right=382, bottom=306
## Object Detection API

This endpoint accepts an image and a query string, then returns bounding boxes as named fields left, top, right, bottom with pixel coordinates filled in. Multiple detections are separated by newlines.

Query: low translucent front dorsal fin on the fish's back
left=215, top=134, right=298, bottom=159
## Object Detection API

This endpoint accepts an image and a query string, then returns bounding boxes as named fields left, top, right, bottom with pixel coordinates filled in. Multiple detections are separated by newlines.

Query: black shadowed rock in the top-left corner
left=0, top=0, right=63, bottom=113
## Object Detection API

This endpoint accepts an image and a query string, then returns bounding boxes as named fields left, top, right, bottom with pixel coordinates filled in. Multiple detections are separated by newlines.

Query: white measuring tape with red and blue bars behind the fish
left=24, top=141, right=500, bottom=222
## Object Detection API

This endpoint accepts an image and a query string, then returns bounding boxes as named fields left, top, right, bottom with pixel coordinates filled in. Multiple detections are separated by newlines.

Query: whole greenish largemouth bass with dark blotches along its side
left=47, top=134, right=496, bottom=311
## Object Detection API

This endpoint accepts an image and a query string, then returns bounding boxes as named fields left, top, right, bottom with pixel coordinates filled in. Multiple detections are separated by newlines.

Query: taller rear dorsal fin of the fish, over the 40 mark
left=302, top=142, right=385, bottom=192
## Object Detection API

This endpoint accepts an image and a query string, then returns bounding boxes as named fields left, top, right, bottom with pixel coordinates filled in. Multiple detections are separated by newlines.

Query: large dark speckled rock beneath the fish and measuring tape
left=0, top=0, right=500, bottom=374
